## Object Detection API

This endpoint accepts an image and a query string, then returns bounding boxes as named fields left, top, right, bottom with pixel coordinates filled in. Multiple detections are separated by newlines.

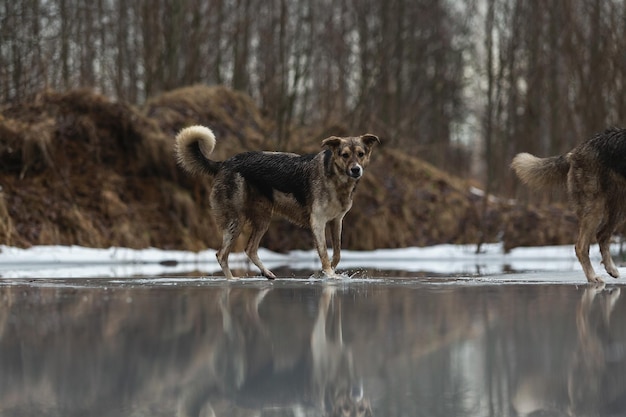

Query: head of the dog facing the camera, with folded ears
left=322, top=134, right=380, bottom=179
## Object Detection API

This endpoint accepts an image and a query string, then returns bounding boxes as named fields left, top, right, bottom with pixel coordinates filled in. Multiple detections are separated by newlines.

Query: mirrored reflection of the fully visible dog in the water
left=177, top=287, right=372, bottom=417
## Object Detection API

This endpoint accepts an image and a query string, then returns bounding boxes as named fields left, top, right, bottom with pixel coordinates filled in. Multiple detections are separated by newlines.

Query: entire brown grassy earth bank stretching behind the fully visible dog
left=0, top=86, right=575, bottom=251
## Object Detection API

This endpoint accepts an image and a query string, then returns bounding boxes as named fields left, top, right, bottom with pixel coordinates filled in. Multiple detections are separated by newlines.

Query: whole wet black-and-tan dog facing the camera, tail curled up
left=176, top=126, right=380, bottom=279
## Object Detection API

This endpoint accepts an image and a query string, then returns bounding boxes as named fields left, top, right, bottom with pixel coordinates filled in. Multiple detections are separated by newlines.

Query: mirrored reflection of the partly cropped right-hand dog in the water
left=512, top=284, right=626, bottom=417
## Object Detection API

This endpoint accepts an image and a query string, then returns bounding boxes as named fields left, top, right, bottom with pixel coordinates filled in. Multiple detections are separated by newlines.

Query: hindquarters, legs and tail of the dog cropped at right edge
left=511, top=128, right=626, bottom=283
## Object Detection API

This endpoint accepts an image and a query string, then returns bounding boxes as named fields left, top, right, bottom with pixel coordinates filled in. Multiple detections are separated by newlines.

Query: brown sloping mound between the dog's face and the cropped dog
left=336, top=146, right=576, bottom=249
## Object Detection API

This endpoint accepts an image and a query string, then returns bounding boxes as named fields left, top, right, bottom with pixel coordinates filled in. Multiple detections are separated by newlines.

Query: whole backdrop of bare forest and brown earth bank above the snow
left=0, top=0, right=626, bottom=250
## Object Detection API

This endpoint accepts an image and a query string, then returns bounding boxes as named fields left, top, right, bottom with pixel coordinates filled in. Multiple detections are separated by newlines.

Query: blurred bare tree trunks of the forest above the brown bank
left=0, top=0, right=626, bottom=195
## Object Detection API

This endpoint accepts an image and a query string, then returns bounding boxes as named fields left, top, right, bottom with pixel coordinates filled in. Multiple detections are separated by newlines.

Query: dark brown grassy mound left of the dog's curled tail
left=0, top=91, right=213, bottom=249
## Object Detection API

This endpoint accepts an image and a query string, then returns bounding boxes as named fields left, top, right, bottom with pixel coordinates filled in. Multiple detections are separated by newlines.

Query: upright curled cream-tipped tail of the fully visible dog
left=175, top=126, right=221, bottom=175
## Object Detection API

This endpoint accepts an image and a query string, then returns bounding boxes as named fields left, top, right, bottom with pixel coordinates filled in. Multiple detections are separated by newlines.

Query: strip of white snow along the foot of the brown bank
left=0, top=239, right=619, bottom=278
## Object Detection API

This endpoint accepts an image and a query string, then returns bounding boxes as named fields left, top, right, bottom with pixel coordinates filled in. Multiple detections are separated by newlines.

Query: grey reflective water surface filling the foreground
left=0, top=279, right=626, bottom=417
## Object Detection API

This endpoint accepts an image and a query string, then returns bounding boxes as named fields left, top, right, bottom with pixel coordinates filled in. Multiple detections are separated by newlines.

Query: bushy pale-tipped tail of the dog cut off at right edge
left=511, top=153, right=570, bottom=189
